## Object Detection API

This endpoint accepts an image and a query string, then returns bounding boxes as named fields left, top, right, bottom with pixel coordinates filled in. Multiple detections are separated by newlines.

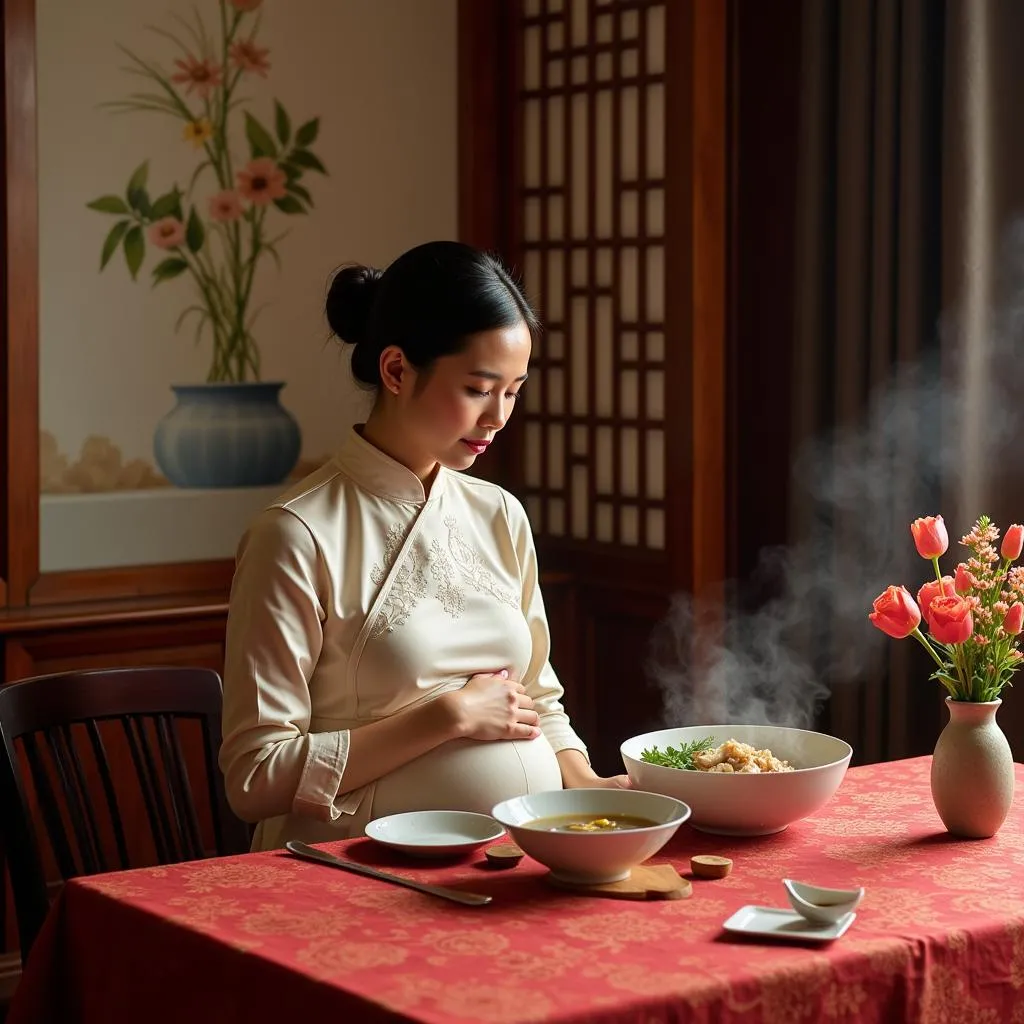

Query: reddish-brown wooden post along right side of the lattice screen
left=666, top=0, right=728, bottom=595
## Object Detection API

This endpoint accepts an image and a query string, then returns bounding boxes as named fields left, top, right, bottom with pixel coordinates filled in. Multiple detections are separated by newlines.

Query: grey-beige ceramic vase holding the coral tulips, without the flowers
left=932, top=697, right=1014, bottom=839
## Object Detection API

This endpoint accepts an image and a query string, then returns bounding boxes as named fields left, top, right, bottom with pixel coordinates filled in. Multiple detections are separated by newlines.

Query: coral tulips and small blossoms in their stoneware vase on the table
left=868, top=516, right=1024, bottom=838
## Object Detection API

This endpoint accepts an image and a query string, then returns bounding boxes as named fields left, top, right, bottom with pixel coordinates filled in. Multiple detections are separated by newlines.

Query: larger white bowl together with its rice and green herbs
left=621, top=725, right=853, bottom=836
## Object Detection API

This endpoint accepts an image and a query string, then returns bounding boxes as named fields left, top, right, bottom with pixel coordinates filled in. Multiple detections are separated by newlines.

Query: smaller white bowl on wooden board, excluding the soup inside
left=490, top=790, right=690, bottom=885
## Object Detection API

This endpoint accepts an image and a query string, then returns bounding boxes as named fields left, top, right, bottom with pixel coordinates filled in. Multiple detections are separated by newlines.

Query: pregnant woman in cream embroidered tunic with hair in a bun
left=220, top=242, right=629, bottom=849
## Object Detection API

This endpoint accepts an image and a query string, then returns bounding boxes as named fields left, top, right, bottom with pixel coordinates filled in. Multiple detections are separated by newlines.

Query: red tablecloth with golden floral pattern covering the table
left=9, top=759, right=1024, bottom=1024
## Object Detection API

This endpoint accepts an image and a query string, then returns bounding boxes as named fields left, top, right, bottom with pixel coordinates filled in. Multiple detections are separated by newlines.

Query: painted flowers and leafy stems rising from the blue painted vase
left=87, top=0, right=327, bottom=382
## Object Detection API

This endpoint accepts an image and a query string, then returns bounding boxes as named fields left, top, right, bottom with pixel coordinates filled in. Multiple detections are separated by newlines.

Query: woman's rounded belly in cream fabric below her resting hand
left=371, top=736, right=562, bottom=818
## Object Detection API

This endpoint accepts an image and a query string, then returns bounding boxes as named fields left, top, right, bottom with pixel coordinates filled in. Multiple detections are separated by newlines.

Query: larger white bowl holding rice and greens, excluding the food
left=620, top=725, right=853, bottom=836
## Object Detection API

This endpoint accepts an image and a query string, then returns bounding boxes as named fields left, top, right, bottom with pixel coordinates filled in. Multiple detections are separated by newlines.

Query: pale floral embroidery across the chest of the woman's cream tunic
left=370, top=516, right=519, bottom=640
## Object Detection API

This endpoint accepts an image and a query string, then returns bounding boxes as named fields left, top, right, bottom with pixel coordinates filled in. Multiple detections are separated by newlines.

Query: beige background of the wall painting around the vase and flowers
left=37, top=0, right=457, bottom=569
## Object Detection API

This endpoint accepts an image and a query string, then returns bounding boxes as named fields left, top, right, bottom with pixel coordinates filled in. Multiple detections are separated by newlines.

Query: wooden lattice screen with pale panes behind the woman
left=514, top=0, right=666, bottom=550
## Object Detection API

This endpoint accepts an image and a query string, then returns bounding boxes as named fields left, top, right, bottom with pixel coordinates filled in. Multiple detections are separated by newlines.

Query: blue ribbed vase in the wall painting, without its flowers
left=154, top=382, right=302, bottom=487
